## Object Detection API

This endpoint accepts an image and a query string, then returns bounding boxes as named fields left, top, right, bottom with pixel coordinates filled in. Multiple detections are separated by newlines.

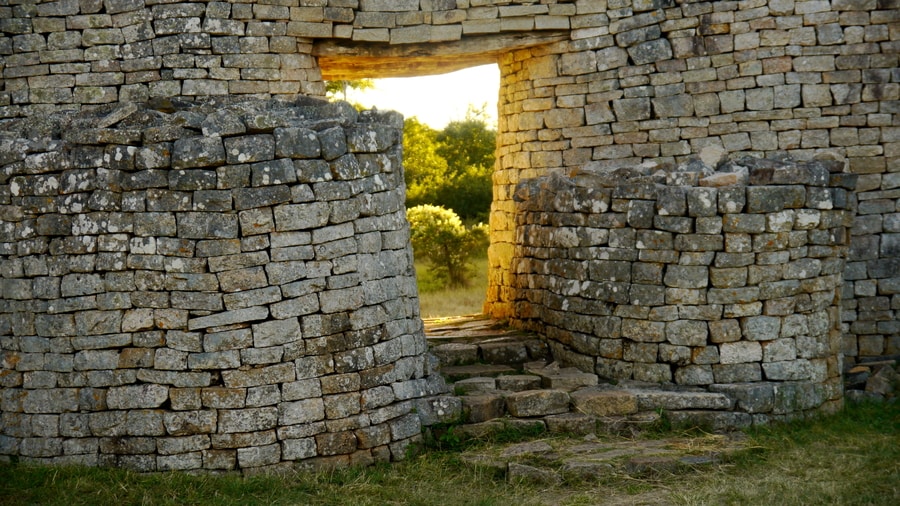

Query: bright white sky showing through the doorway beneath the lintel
left=347, top=65, right=500, bottom=130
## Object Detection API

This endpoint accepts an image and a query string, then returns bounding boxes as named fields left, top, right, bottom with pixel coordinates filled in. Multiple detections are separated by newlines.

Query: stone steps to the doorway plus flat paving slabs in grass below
left=422, top=316, right=751, bottom=484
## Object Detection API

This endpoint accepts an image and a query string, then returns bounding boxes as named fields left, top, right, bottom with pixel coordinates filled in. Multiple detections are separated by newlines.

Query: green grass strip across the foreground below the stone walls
left=0, top=403, right=900, bottom=506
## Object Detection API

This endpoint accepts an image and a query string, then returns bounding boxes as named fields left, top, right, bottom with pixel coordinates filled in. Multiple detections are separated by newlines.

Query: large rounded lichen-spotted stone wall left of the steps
left=0, top=100, right=452, bottom=471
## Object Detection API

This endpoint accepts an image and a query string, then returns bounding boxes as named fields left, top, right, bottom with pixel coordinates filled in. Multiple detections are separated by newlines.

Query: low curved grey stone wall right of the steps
left=510, top=158, right=856, bottom=414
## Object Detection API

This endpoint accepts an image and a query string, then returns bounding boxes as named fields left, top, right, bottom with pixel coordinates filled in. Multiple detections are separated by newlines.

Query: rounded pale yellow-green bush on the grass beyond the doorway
left=406, top=204, right=487, bottom=287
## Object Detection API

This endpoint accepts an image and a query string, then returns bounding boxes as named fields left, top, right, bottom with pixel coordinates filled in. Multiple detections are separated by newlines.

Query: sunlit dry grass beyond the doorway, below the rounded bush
left=415, top=253, right=488, bottom=318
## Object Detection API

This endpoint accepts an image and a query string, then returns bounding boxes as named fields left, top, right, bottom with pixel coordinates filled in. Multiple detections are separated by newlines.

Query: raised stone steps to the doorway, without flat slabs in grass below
left=425, top=316, right=752, bottom=436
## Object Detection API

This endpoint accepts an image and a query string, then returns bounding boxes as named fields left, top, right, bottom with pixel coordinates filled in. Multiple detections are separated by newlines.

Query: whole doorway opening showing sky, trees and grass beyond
left=329, top=64, right=500, bottom=319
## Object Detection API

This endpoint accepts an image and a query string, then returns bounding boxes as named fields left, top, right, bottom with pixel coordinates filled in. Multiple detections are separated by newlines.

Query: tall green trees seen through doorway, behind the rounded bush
left=403, top=107, right=497, bottom=221
